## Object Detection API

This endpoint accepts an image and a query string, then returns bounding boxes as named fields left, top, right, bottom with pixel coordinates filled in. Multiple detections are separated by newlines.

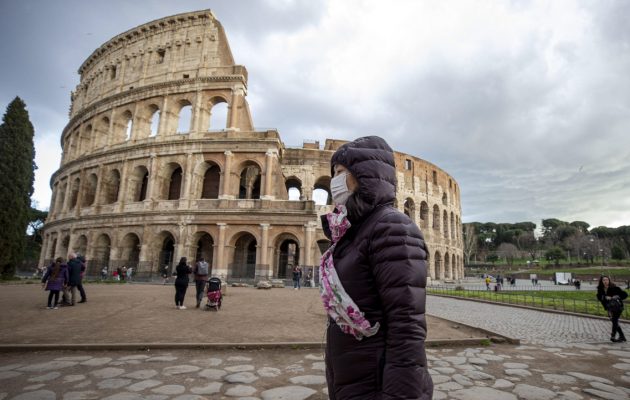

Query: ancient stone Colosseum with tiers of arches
left=40, top=10, right=463, bottom=281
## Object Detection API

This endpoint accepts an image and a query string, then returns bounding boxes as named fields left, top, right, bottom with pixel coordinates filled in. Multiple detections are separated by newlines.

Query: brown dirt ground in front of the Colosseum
left=0, top=284, right=486, bottom=344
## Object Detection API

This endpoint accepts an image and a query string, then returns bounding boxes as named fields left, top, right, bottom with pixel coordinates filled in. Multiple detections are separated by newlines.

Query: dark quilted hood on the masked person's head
left=330, top=136, right=396, bottom=223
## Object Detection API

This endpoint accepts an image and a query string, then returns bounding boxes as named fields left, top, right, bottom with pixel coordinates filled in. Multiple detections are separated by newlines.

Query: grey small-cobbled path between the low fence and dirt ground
left=427, top=296, right=630, bottom=344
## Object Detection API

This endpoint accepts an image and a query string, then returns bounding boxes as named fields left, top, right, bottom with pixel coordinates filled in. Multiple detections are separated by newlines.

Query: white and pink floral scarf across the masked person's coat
left=319, top=205, right=380, bottom=340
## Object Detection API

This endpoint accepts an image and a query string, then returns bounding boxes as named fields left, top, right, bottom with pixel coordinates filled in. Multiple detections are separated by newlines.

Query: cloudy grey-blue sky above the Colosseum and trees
left=0, top=0, right=630, bottom=226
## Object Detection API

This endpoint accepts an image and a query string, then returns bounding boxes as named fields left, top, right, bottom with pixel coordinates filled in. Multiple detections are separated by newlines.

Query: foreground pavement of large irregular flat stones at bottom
left=0, top=344, right=630, bottom=400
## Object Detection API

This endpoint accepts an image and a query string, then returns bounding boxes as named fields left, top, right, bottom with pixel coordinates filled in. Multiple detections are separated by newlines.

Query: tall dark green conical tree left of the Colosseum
left=0, top=97, right=37, bottom=278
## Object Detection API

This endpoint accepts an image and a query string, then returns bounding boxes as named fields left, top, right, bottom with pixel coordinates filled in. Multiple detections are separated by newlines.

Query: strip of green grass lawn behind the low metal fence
left=428, top=288, right=630, bottom=319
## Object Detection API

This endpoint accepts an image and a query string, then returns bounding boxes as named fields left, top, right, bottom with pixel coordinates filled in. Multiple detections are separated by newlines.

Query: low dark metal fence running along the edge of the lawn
left=427, top=286, right=630, bottom=320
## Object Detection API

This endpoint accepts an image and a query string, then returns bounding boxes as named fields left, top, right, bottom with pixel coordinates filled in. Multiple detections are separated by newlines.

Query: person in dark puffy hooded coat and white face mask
left=319, top=136, right=433, bottom=400
